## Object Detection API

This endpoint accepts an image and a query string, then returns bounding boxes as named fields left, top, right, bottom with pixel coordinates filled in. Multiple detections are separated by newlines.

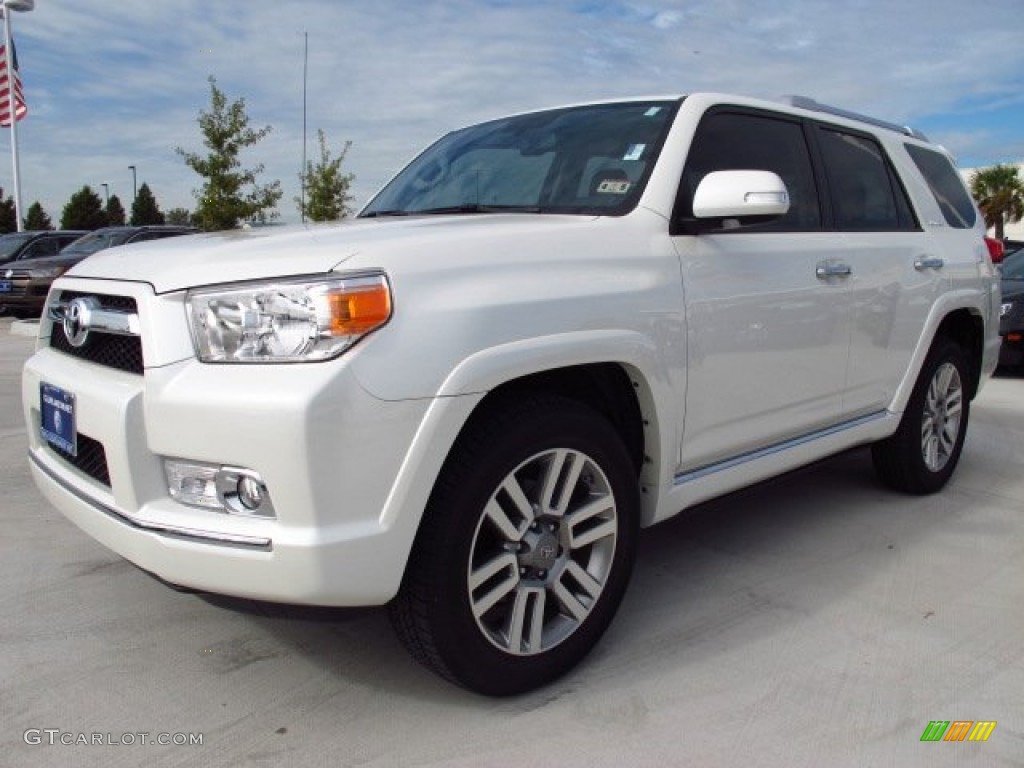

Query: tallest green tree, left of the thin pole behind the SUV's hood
left=176, top=77, right=282, bottom=230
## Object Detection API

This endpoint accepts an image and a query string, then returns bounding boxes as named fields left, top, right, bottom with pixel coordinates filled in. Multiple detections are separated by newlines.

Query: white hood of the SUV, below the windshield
left=69, top=213, right=589, bottom=293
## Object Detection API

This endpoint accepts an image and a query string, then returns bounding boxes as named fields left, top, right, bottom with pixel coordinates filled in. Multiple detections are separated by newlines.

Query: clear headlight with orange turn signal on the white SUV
left=186, top=274, right=391, bottom=362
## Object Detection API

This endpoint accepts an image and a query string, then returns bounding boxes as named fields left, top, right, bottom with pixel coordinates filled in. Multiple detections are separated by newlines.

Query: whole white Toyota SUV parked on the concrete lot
left=23, top=94, right=999, bottom=694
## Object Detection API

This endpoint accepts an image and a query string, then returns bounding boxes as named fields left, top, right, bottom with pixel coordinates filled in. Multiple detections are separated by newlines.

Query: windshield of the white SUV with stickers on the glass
left=360, top=101, right=678, bottom=217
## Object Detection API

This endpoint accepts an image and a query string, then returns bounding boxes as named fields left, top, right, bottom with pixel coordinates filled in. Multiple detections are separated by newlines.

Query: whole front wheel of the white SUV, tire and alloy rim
left=390, top=394, right=640, bottom=696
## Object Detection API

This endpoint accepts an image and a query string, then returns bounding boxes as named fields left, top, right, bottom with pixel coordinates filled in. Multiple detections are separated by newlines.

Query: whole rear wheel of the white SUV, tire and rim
left=871, top=338, right=971, bottom=495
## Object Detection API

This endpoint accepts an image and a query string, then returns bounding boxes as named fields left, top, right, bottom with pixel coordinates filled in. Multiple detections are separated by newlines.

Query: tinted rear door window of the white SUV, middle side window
left=818, top=127, right=916, bottom=231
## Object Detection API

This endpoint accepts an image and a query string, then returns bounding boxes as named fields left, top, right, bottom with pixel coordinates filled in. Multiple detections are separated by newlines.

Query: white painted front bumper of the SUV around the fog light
left=23, top=276, right=432, bottom=605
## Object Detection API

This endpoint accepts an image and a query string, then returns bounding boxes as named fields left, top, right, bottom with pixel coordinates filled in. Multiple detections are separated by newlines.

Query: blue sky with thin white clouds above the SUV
left=0, top=0, right=1024, bottom=223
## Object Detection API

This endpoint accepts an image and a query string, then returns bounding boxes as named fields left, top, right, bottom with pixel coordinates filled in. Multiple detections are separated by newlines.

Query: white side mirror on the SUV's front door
left=693, top=171, right=790, bottom=229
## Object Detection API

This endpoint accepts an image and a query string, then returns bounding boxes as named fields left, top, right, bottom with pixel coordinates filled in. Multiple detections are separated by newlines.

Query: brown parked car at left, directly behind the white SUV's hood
left=0, top=224, right=198, bottom=317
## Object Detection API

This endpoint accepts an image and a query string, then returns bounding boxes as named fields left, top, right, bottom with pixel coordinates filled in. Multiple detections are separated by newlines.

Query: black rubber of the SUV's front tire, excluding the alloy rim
left=425, top=398, right=639, bottom=695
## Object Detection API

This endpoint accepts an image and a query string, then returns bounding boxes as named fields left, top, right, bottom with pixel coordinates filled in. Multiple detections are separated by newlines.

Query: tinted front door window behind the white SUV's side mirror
left=679, top=112, right=821, bottom=231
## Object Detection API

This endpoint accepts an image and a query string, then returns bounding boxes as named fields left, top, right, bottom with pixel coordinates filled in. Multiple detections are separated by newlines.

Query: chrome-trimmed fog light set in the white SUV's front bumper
left=164, top=459, right=276, bottom=517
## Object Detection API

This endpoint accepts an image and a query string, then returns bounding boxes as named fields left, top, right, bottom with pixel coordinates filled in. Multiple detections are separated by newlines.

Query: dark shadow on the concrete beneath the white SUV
left=157, top=450, right=950, bottom=711
